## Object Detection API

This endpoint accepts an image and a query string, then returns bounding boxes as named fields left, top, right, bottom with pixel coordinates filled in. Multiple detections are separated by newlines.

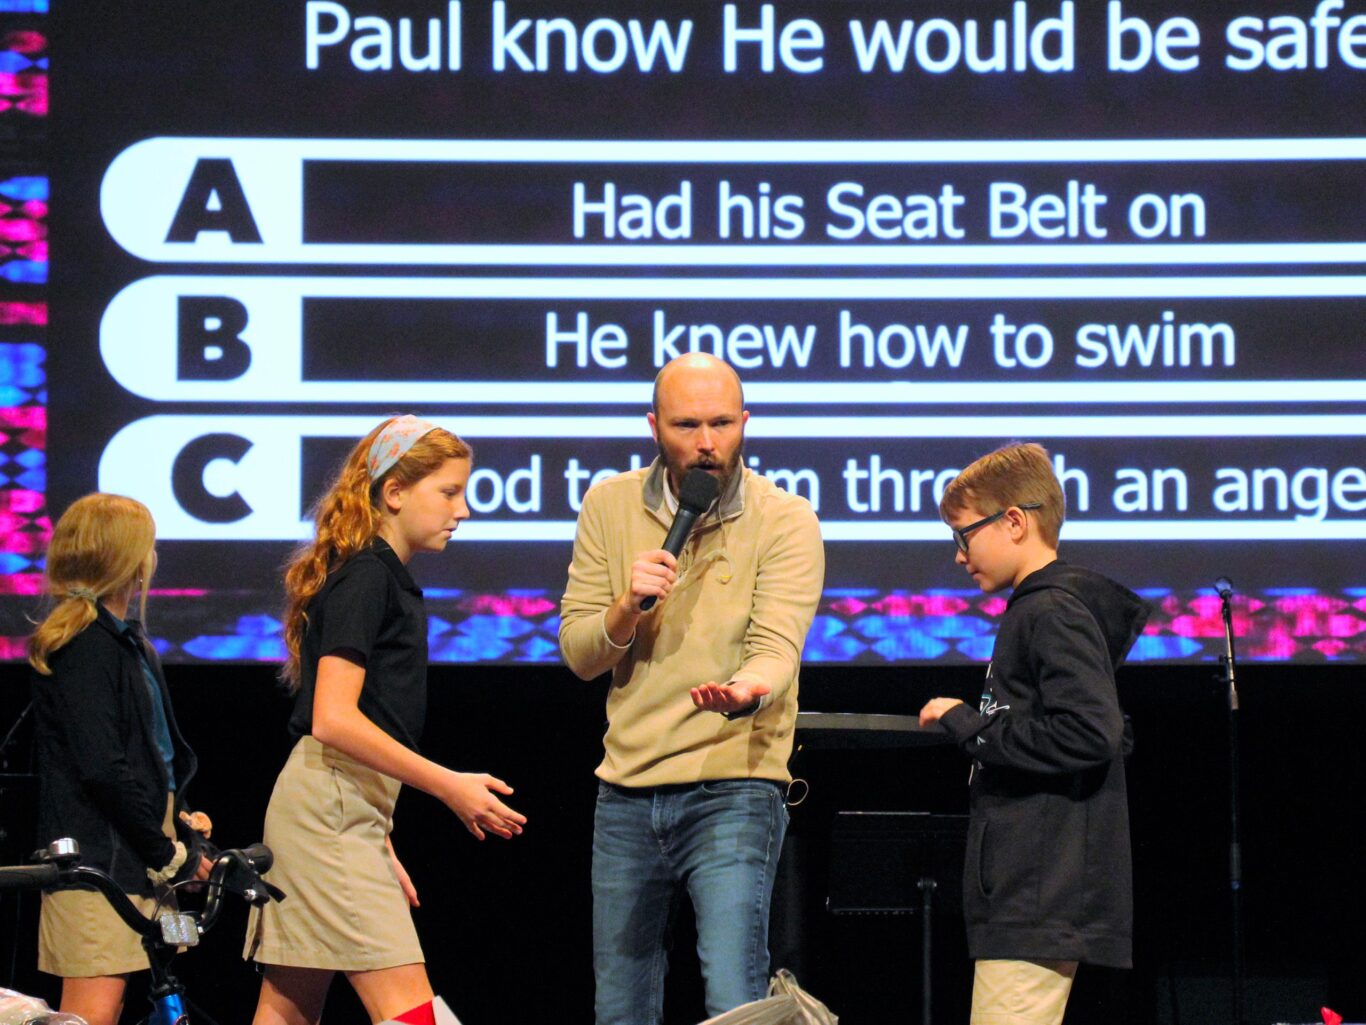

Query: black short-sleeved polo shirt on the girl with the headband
left=290, top=537, right=428, bottom=750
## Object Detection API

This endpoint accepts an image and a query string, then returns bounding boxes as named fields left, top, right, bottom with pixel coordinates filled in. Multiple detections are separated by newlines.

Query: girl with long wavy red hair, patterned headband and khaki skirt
left=246, top=417, right=526, bottom=1025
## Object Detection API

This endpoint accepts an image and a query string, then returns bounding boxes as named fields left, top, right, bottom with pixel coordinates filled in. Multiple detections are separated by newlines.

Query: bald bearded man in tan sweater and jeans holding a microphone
left=560, top=353, right=825, bottom=1025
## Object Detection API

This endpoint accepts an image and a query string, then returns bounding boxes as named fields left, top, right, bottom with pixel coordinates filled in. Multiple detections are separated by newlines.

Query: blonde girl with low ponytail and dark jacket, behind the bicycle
left=29, top=493, right=209, bottom=1025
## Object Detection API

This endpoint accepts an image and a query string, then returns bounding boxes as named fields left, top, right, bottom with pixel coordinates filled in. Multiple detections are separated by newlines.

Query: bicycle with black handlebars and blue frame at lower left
left=0, top=839, right=284, bottom=1025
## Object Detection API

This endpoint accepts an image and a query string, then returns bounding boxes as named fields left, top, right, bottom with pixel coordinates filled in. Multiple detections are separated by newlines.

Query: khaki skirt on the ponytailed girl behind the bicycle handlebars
left=38, top=794, right=175, bottom=979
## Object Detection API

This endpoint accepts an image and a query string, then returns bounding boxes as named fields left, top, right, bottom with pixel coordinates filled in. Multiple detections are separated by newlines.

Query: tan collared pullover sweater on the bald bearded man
left=560, top=461, right=825, bottom=787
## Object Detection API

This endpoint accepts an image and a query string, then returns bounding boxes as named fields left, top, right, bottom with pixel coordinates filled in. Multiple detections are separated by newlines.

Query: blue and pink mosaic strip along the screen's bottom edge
left=69, top=588, right=1366, bottom=664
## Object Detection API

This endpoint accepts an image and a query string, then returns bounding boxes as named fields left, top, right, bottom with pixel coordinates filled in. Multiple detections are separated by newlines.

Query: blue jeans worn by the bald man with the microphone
left=593, top=779, right=787, bottom=1025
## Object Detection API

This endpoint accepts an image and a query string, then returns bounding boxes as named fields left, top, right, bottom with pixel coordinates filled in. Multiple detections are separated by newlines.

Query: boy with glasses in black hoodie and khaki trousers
left=921, top=444, right=1149, bottom=1025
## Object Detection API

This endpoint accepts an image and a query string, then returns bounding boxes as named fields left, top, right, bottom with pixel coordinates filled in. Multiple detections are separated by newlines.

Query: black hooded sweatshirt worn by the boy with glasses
left=943, top=560, right=1150, bottom=968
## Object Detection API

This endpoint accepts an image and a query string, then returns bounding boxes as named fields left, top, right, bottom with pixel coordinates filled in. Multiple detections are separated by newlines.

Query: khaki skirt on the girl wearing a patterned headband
left=243, top=737, right=425, bottom=972
